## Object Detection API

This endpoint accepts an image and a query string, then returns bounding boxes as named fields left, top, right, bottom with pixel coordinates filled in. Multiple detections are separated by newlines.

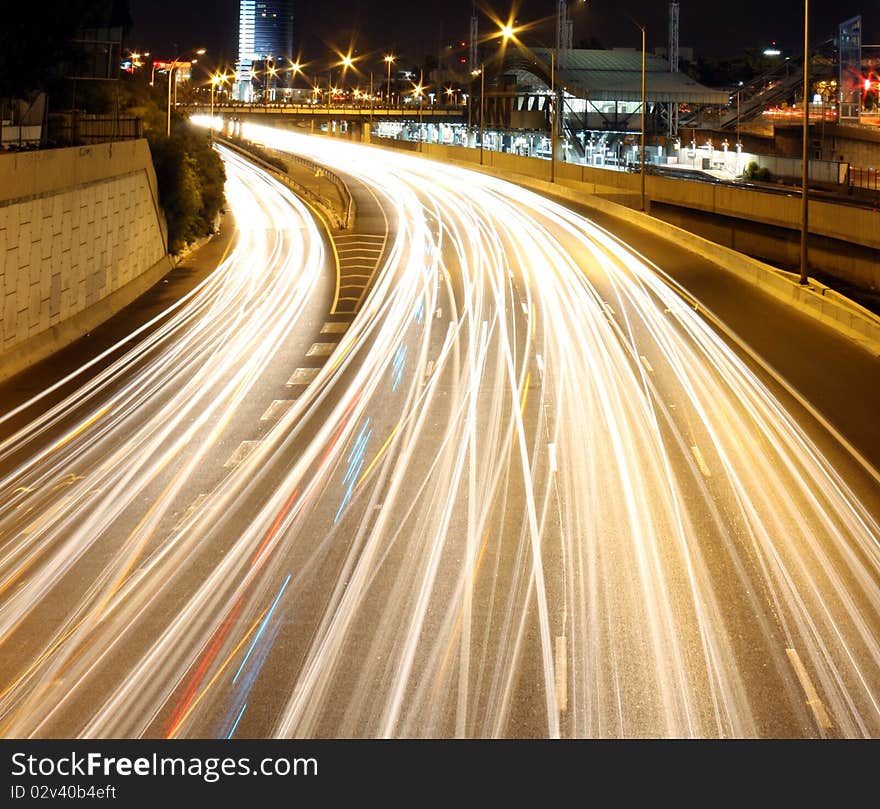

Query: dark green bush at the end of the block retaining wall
left=149, top=122, right=226, bottom=253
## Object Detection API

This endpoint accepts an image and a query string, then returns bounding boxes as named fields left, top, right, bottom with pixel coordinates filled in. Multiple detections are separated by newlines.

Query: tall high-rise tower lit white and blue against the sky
left=235, top=0, right=293, bottom=101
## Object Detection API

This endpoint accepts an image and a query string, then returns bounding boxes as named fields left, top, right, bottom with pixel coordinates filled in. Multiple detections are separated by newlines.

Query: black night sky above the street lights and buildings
left=130, top=0, right=880, bottom=69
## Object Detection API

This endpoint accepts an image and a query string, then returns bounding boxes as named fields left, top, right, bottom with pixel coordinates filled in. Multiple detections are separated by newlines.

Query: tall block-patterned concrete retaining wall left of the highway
left=0, top=140, right=172, bottom=379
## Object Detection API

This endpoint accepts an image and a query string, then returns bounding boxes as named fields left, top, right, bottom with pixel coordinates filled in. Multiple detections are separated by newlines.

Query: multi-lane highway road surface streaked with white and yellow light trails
left=0, top=127, right=880, bottom=738
